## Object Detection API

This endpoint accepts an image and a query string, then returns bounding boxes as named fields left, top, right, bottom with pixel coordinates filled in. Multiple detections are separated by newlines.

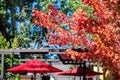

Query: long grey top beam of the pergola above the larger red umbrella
left=0, top=48, right=66, bottom=54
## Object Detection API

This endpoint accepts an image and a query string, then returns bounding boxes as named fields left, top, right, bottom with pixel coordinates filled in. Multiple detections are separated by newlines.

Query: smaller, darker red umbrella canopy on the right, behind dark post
left=58, top=67, right=102, bottom=76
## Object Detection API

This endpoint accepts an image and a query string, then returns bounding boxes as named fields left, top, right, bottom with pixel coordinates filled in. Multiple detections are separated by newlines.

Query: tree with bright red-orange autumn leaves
left=32, top=0, right=120, bottom=80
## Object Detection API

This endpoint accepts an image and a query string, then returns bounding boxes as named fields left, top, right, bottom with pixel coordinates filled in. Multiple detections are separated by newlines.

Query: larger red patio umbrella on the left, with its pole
left=7, top=59, right=62, bottom=79
